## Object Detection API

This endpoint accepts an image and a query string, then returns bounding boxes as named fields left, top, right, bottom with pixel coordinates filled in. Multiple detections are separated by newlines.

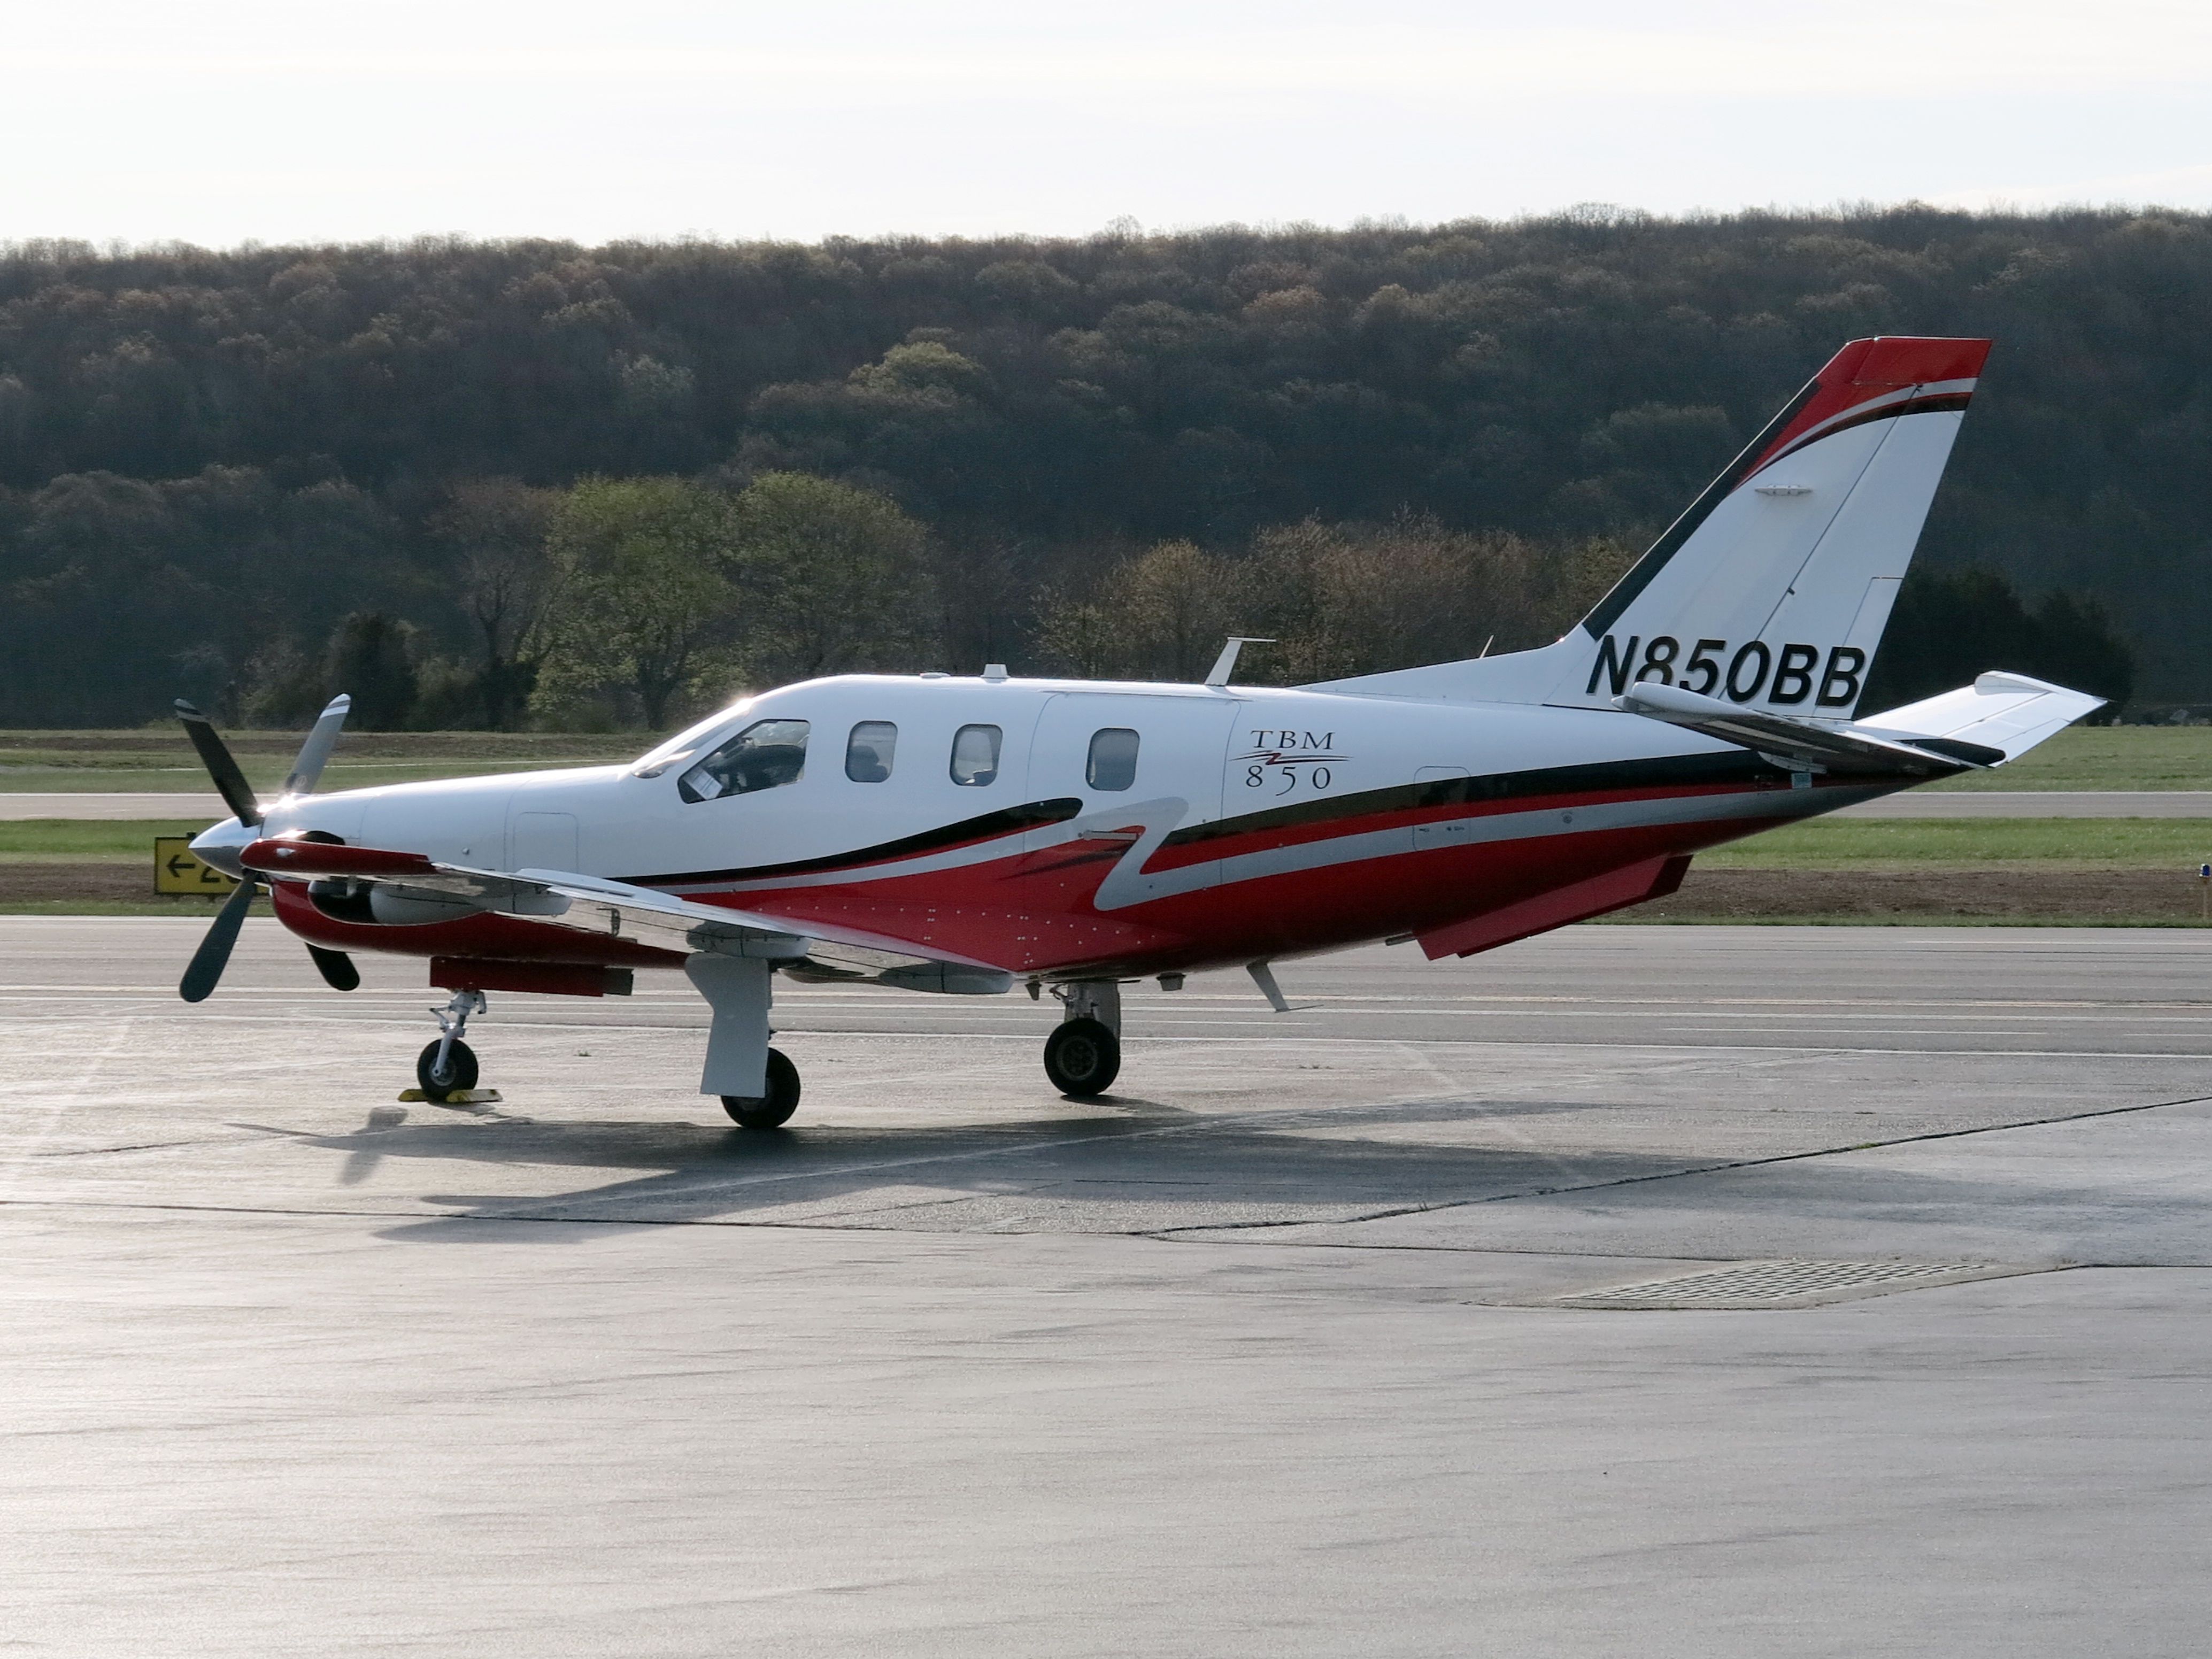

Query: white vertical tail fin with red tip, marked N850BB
left=1331, top=336, right=1989, bottom=721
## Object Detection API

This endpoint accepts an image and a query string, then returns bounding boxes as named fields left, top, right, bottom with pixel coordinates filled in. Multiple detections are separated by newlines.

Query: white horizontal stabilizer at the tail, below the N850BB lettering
left=1613, top=675, right=2103, bottom=776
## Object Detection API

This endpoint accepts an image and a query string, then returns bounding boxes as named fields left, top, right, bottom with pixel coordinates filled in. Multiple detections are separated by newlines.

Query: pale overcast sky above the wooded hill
left=0, top=0, right=2212, bottom=245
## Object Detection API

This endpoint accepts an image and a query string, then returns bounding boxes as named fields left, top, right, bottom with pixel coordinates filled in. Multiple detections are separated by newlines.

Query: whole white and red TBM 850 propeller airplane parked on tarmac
left=177, top=336, right=2101, bottom=1128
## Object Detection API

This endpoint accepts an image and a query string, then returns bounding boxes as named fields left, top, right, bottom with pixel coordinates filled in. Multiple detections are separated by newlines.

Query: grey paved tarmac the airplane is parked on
left=0, top=924, right=2212, bottom=1655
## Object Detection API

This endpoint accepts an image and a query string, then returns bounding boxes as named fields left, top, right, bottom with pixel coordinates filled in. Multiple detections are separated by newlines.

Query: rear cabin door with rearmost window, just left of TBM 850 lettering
left=1029, top=692, right=1239, bottom=898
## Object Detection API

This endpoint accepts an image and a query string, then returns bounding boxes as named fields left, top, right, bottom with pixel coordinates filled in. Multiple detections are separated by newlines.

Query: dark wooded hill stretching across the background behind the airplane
left=0, top=206, right=2185, bottom=726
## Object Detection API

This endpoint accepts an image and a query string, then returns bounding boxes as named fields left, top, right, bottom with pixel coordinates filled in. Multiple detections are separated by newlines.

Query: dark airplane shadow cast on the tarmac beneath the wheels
left=251, top=1095, right=1787, bottom=1241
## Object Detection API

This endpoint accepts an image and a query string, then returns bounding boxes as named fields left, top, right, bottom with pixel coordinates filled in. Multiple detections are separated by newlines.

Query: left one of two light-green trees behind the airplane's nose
left=531, top=478, right=737, bottom=732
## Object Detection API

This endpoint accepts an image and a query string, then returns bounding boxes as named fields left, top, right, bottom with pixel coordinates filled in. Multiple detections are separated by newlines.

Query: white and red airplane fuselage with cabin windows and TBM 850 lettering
left=215, top=675, right=1920, bottom=978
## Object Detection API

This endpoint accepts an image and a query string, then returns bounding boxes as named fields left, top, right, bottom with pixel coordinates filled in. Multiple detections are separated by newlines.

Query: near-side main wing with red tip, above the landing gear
left=239, top=840, right=1013, bottom=996
